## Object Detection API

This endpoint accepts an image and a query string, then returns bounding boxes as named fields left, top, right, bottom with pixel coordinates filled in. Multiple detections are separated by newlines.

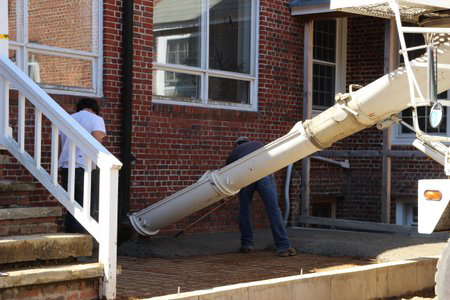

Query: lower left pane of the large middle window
left=153, top=70, right=201, bottom=102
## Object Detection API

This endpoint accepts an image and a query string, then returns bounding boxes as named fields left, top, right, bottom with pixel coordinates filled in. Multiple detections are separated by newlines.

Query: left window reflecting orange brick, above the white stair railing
left=8, top=0, right=103, bottom=96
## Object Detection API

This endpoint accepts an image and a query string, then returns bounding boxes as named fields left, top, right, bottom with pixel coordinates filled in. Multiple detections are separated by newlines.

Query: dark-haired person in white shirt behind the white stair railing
left=58, top=98, right=106, bottom=233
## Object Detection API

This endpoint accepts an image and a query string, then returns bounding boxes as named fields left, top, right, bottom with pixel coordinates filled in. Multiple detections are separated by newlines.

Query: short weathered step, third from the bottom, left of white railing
left=0, top=207, right=62, bottom=237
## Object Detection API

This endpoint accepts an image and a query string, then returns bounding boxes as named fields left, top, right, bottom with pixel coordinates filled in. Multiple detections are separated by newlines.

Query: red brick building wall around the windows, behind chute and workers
left=3, top=0, right=442, bottom=234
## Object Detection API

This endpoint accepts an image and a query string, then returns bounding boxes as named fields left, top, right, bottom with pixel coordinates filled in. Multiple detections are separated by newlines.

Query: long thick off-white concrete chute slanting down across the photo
left=130, top=43, right=450, bottom=235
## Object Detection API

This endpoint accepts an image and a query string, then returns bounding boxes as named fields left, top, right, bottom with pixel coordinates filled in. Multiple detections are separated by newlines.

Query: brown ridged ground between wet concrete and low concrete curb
left=117, top=250, right=374, bottom=300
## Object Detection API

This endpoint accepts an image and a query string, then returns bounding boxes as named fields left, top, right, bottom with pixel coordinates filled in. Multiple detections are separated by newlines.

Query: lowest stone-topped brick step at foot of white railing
left=0, top=263, right=103, bottom=299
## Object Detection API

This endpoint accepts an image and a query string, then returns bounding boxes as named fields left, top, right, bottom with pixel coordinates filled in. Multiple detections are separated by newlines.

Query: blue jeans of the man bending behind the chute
left=239, top=175, right=290, bottom=252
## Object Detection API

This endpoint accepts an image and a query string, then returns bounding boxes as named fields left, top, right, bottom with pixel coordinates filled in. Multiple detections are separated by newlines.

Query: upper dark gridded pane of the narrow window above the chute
left=313, top=20, right=337, bottom=63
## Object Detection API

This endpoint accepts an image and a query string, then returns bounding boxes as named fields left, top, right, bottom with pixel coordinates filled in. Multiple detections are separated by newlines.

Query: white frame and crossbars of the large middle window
left=152, top=0, right=259, bottom=111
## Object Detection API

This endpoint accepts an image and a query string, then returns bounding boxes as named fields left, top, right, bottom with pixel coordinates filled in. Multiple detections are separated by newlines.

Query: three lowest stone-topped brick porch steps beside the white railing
left=0, top=207, right=103, bottom=299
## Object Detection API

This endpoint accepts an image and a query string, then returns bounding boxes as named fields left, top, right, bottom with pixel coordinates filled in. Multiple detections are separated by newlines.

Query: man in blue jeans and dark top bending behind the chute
left=226, top=136, right=297, bottom=257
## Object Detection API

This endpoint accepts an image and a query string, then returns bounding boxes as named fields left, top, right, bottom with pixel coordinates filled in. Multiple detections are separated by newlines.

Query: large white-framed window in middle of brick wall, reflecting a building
left=153, top=0, right=257, bottom=110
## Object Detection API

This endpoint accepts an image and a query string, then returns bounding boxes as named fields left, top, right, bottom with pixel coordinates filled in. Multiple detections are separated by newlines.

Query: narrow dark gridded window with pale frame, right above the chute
left=313, top=19, right=347, bottom=110
